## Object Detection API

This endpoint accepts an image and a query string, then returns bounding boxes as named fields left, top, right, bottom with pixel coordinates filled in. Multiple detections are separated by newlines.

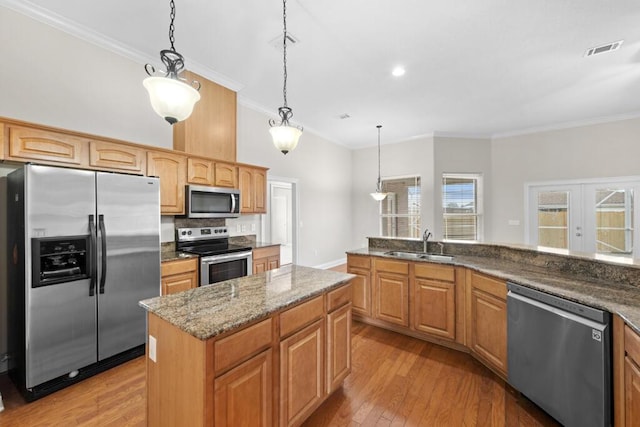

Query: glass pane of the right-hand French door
left=595, top=188, right=633, bottom=255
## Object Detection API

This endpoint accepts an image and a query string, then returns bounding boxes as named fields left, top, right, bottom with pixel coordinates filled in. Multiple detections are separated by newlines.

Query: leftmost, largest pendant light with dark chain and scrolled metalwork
left=142, top=0, right=200, bottom=124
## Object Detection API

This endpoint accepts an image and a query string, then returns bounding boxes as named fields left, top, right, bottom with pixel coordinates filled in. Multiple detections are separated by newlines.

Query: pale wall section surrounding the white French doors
left=491, top=118, right=640, bottom=243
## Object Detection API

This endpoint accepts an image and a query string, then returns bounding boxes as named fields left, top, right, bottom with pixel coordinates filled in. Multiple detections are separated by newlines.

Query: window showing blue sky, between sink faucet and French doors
left=442, top=173, right=482, bottom=241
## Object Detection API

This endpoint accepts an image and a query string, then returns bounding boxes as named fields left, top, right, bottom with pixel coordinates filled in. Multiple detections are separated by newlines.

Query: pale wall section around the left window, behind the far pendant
left=351, top=137, right=434, bottom=248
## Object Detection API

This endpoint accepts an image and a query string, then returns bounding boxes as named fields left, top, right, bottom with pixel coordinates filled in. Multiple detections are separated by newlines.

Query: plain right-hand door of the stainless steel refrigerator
left=96, top=172, right=160, bottom=360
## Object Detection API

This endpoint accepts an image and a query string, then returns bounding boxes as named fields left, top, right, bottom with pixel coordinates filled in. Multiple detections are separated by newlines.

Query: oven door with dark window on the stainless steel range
left=200, top=251, right=253, bottom=286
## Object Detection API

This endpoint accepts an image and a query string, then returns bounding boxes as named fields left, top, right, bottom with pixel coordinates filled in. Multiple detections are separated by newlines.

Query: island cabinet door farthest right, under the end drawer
left=327, top=304, right=351, bottom=393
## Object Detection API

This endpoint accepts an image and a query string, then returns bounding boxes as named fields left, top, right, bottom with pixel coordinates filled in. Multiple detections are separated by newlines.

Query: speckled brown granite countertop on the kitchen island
left=140, top=265, right=355, bottom=340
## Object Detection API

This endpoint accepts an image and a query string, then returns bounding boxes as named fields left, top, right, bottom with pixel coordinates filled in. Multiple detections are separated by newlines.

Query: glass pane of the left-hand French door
left=538, top=191, right=569, bottom=249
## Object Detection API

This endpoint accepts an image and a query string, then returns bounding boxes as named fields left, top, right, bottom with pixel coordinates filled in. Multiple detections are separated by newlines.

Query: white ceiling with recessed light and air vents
left=0, top=0, right=640, bottom=148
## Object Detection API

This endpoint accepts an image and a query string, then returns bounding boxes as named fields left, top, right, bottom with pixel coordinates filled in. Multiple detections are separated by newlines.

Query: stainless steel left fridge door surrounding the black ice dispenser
left=23, top=165, right=97, bottom=388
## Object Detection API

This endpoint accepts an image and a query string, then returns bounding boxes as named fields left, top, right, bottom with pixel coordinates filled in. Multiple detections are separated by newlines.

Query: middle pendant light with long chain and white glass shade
left=269, top=0, right=302, bottom=154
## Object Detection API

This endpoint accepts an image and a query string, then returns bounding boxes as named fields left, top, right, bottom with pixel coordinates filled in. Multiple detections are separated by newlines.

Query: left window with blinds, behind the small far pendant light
left=380, top=176, right=421, bottom=237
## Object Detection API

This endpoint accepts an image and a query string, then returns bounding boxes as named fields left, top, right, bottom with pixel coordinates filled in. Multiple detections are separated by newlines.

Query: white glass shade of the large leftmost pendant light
left=142, top=77, right=200, bottom=124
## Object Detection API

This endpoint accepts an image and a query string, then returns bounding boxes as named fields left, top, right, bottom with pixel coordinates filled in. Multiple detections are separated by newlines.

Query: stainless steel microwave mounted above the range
left=185, top=185, right=240, bottom=218
